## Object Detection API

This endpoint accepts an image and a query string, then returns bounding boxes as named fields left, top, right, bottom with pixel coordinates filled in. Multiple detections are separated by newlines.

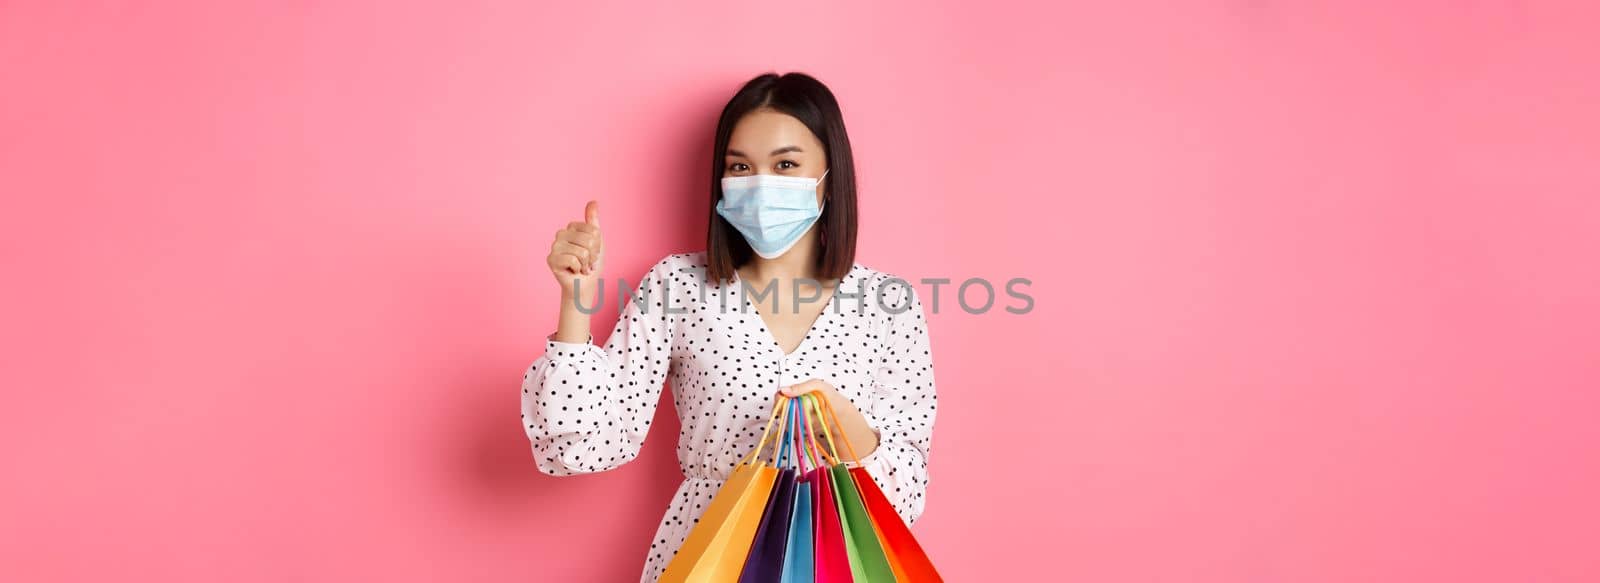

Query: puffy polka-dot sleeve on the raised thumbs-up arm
left=522, top=259, right=675, bottom=476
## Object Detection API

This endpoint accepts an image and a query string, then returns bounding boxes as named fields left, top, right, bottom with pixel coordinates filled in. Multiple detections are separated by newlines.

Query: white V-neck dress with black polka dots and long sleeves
left=522, top=253, right=938, bottom=583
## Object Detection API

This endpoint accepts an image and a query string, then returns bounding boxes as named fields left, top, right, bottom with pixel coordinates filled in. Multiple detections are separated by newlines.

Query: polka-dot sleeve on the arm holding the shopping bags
left=861, top=285, right=938, bottom=525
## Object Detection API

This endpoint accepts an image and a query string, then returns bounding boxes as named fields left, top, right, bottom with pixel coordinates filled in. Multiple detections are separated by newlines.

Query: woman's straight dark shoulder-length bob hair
left=706, top=72, right=856, bottom=282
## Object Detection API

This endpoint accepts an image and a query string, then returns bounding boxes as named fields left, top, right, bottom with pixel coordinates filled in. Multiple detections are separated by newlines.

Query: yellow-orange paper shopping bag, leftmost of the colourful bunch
left=658, top=396, right=789, bottom=583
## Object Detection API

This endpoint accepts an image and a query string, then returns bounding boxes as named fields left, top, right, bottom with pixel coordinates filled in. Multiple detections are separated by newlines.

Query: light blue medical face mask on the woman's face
left=717, top=170, right=827, bottom=259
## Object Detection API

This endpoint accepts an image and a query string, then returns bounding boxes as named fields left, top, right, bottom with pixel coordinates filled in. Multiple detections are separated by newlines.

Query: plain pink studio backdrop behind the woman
left=0, top=0, right=1600, bottom=583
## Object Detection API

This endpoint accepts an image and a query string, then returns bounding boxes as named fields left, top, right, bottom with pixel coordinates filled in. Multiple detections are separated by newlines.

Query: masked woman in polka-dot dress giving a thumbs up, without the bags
left=522, top=74, right=936, bottom=581
